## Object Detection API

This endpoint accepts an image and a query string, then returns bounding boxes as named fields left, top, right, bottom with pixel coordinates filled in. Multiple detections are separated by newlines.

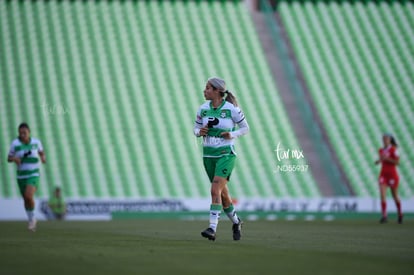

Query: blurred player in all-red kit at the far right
left=375, top=134, right=403, bottom=224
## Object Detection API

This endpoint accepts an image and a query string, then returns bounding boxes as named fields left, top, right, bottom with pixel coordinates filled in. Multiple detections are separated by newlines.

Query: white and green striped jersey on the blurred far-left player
left=9, top=138, right=43, bottom=179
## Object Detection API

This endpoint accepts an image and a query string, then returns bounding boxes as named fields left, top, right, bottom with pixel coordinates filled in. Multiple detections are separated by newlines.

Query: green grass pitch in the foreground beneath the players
left=0, top=219, right=414, bottom=275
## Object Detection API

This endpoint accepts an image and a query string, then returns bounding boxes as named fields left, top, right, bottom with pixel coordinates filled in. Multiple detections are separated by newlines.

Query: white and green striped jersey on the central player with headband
left=194, top=101, right=249, bottom=158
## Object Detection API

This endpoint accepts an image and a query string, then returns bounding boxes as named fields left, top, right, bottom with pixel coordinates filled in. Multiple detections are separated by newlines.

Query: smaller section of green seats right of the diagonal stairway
left=277, top=1, right=414, bottom=197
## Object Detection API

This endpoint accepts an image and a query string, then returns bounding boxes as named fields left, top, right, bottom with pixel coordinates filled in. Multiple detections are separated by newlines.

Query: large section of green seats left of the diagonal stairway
left=0, top=1, right=320, bottom=198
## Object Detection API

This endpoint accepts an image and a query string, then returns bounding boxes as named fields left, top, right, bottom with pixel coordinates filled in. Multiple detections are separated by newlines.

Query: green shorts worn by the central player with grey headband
left=203, top=154, right=236, bottom=182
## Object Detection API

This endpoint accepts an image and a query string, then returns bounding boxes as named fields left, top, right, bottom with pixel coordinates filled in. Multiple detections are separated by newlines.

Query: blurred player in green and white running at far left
left=7, top=122, right=46, bottom=231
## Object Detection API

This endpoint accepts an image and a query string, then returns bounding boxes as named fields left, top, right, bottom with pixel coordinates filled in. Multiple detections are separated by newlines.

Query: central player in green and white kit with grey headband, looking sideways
left=194, top=77, right=249, bottom=241
